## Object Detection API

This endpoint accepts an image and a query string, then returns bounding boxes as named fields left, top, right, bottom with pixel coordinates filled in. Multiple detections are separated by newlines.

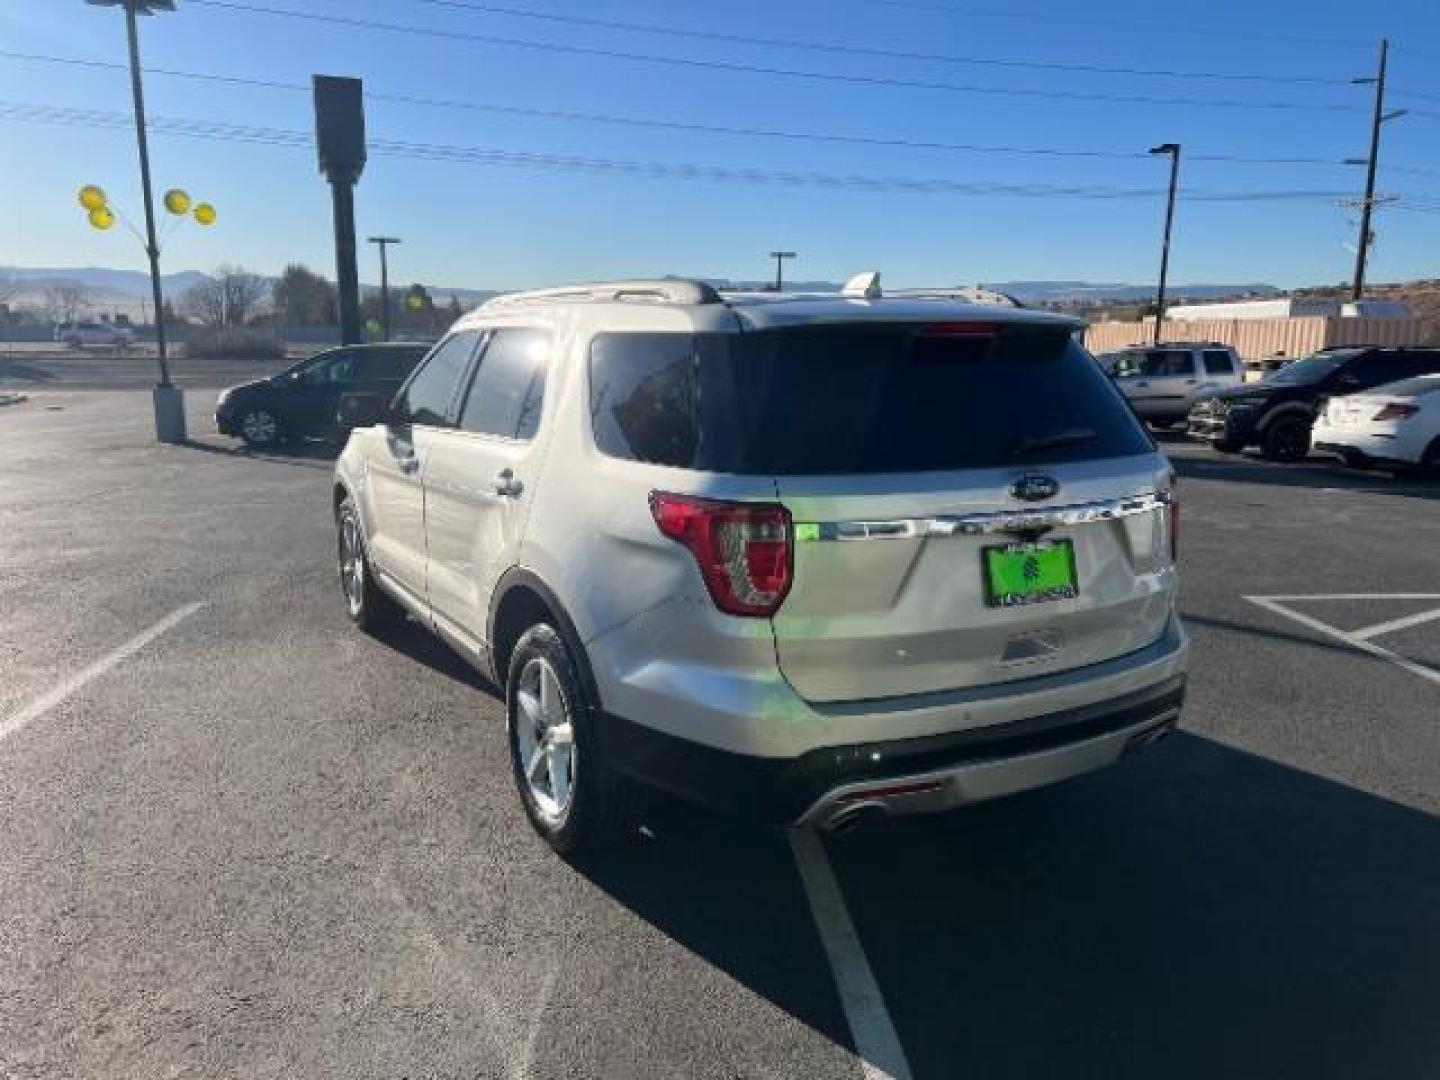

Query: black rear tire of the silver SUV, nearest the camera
left=505, top=622, right=644, bottom=857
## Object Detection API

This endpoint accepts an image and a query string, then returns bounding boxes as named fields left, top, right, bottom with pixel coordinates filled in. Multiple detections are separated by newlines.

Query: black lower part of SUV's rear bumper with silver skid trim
left=603, top=675, right=1185, bottom=825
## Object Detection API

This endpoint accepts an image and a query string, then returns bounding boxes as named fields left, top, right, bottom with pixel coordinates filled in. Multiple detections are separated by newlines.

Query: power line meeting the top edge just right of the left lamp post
left=189, top=0, right=1365, bottom=112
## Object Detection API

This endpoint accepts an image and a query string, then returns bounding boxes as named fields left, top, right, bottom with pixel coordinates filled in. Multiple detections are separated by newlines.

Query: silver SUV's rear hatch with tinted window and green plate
left=714, top=320, right=1174, bottom=701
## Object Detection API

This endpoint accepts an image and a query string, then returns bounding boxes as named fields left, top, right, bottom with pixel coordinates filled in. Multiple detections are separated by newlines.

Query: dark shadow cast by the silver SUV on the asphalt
left=580, top=734, right=1440, bottom=1080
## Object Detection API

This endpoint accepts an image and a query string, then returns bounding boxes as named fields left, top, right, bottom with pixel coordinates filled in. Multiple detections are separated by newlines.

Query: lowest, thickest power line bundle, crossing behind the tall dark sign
left=0, top=101, right=1382, bottom=203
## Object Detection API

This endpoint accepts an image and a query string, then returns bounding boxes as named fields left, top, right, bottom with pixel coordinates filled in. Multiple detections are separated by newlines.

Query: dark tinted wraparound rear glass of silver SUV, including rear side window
left=590, top=323, right=1152, bottom=475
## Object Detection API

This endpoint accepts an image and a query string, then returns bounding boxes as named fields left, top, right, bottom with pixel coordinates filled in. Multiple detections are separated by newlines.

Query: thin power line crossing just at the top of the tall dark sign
left=0, top=50, right=1376, bottom=167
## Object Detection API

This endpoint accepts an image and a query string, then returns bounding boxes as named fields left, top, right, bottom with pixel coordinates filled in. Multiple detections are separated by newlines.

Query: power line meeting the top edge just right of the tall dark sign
left=413, top=0, right=1349, bottom=86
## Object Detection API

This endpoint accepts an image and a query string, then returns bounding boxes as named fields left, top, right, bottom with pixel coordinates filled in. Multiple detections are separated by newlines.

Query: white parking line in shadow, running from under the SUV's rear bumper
left=791, top=829, right=910, bottom=1080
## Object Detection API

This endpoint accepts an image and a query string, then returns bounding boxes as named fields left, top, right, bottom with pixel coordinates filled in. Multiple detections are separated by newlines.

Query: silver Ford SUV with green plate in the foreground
left=334, top=274, right=1187, bottom=852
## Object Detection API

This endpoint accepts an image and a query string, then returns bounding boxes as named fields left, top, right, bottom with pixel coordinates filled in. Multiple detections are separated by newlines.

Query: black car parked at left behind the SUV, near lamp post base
left=215, top=343, right=431, bottom=446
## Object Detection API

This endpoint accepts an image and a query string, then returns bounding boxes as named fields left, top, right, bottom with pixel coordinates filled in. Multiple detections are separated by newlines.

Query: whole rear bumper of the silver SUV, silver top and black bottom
left=592, top=616, right=1188, bottom=822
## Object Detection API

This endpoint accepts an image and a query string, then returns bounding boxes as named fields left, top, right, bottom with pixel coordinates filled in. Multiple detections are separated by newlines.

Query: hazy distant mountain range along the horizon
left=0, top=266, right=1280, bottom=307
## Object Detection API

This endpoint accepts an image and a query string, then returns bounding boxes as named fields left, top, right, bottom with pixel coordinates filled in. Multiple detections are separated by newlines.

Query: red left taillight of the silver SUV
left=649, top=491, right=793, bottom=618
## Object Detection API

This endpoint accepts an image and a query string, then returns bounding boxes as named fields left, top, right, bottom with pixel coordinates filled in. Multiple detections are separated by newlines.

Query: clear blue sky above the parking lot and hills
left=0, top=0, right=1440, bottom=288
